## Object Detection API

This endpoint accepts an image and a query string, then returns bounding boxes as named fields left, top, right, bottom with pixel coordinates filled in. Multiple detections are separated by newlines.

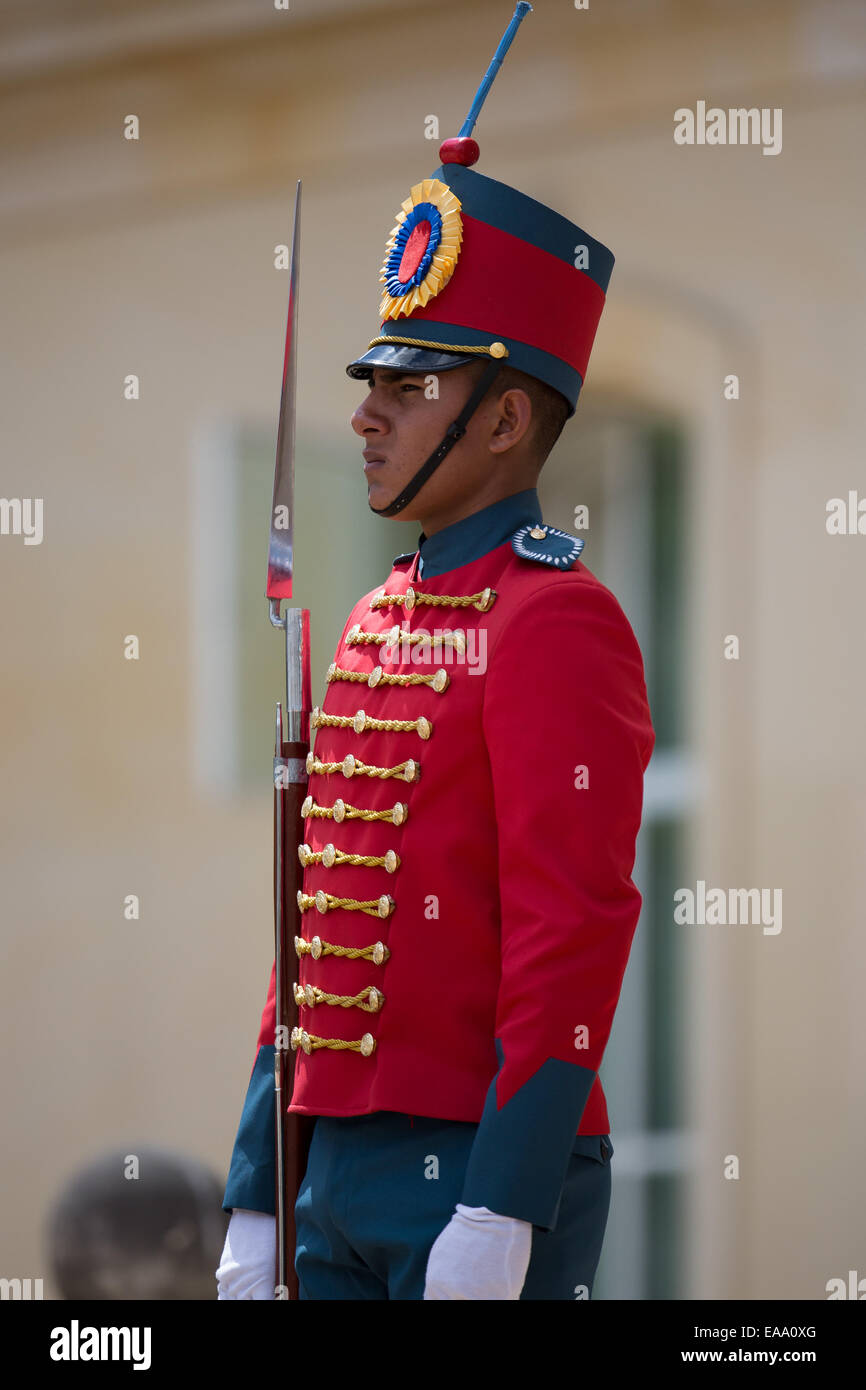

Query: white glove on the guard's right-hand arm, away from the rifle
left=424, top=1202, right=532, bottom=1300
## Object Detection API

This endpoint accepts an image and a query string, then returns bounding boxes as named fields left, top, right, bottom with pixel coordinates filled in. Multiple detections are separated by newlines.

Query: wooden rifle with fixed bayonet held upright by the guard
left=265, top=179, right=314, bottom=1300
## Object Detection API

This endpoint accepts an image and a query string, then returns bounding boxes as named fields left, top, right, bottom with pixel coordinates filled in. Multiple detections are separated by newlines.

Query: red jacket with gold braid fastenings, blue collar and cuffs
left=224, top=489, right=653, bottom=1282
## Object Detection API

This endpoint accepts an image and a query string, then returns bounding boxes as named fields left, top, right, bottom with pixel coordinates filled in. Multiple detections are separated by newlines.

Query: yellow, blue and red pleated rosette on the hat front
left=379, top=178, right=463, bottom=321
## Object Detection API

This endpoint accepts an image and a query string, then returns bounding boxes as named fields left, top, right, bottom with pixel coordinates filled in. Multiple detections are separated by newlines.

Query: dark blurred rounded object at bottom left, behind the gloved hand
left=47, top=1147, right=228, bottom=1300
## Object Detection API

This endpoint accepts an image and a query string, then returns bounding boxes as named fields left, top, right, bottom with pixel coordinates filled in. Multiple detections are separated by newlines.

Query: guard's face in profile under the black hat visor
left=350, top=363, right=489, bottom=521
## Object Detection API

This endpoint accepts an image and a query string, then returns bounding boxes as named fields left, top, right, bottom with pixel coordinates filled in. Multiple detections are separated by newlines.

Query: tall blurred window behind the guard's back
left=539, top=400, right=696, bottom=1298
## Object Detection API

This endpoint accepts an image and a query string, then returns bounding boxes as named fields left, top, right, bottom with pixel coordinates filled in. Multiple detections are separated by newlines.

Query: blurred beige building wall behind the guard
left=0, top=0, right=866, bottom=1298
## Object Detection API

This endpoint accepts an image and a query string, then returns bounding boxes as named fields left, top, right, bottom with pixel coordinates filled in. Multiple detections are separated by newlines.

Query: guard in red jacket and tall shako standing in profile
left=217, top=8, right=655, bottom=1300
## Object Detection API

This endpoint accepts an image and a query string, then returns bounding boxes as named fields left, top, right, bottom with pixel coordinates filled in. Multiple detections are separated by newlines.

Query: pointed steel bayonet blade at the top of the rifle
left=265, top=179, right=300, bottom=613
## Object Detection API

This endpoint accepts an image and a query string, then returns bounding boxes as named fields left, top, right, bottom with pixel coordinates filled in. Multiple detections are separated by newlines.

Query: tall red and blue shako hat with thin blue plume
left=346, top=3, right=613, bottom=416
